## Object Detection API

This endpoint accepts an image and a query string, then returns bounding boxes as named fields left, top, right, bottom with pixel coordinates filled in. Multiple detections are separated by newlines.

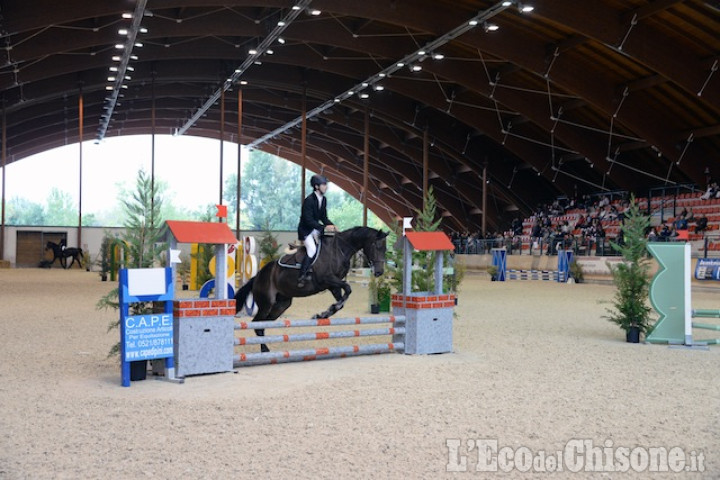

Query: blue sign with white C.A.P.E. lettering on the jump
left=122, top=313, right=173, bottom=362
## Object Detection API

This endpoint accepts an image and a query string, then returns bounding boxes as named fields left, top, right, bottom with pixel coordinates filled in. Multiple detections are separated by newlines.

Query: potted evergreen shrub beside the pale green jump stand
left=605, top=196, right=651, bottom=334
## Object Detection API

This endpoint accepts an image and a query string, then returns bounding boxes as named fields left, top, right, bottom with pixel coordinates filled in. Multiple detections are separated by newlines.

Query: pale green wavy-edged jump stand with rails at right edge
left=646, top=243, right=720, bottom=348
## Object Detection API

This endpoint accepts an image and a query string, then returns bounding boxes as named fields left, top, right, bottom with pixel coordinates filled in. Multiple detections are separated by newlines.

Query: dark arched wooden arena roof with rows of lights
left=0, top=0, right=720, bottom=230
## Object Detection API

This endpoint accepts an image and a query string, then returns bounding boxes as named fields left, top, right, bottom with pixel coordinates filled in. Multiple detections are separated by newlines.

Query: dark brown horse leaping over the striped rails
left=235, top=227, right=388, bottom=352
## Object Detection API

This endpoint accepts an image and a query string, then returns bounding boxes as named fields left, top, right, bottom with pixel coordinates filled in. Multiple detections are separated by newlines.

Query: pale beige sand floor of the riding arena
left=0, top=269, right=720, bottom=479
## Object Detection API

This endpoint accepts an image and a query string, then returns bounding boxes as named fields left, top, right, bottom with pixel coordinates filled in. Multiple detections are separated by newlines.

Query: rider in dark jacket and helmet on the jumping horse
left=298, top=175, right=336, bottom=288
